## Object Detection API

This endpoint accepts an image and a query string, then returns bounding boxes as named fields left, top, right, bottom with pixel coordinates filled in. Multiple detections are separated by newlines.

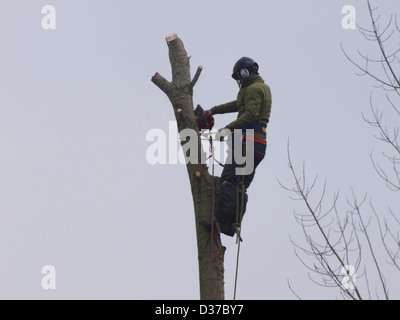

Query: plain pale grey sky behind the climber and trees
left=0, top=0, right=400, bottom=299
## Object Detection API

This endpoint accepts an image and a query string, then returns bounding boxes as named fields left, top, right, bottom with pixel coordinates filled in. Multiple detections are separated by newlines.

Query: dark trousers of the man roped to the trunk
left=215, top=133, right=267, bottom=236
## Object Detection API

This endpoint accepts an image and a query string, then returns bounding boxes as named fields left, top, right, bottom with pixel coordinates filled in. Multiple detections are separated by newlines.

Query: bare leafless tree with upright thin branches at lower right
left=281, top=150, right=389, bottom=300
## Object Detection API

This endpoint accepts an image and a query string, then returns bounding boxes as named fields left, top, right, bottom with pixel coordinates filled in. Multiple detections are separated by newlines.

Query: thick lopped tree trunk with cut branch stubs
left=151, top=34, right=225, bottom=300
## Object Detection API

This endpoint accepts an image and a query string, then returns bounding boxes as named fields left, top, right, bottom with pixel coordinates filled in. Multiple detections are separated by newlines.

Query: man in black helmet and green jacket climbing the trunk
left=199, top=57, right=272, bottom=236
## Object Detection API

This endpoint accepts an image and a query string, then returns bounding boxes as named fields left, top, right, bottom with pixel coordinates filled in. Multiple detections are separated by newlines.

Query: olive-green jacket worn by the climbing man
left=211, top=75, right=272, bottom=130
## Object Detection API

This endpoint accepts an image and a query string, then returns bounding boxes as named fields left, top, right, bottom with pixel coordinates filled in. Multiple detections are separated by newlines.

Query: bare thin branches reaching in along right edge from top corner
left=343, top=1, right=400, bottom=280
